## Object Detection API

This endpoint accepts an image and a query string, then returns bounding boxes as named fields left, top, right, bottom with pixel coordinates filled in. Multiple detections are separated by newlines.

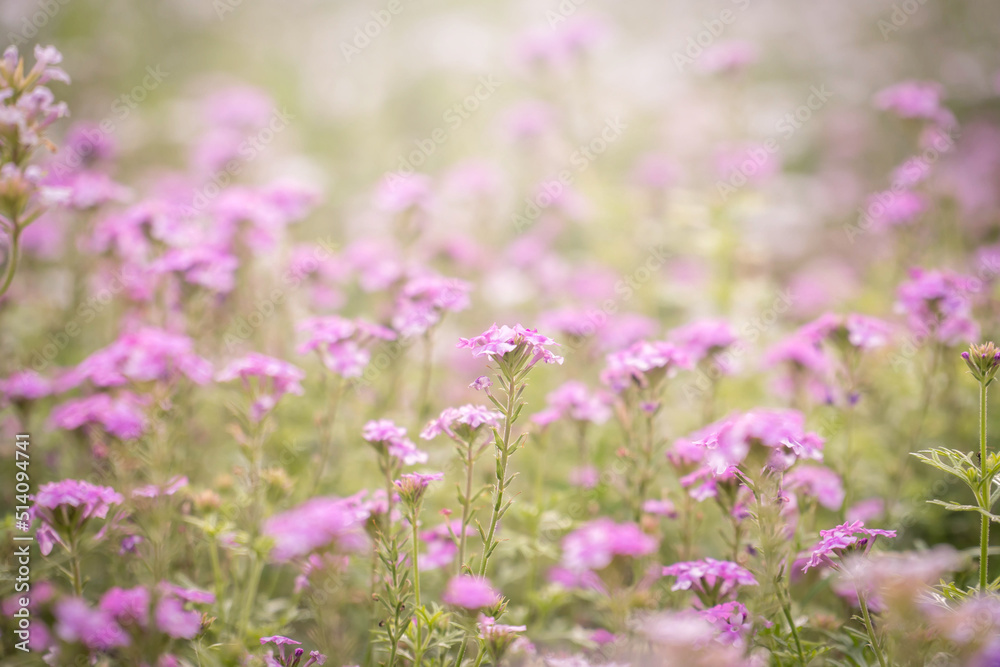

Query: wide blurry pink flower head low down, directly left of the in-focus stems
left=262, top=494, right=368, bottom=563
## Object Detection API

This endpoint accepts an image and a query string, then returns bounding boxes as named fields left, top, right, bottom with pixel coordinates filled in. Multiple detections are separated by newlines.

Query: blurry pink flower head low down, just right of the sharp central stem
left=560, top=518, right=657, bottom=572
